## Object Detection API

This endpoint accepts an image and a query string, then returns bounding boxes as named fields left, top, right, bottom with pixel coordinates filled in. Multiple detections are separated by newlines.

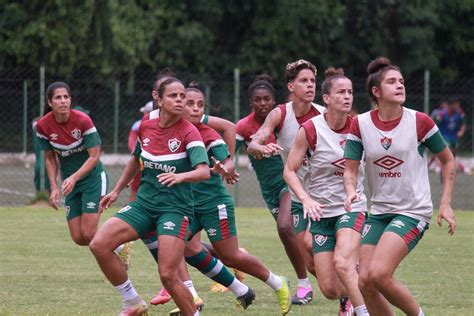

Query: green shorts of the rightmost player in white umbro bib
left=361, top=214, right=429, bottom=252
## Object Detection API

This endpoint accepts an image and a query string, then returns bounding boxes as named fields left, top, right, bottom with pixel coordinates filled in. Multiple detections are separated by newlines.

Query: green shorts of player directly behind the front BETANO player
left=189, top=200, right=237, bottom=242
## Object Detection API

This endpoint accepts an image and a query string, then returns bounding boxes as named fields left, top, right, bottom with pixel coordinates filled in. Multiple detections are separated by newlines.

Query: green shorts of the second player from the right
left=310, top=212, right=366, bottom=254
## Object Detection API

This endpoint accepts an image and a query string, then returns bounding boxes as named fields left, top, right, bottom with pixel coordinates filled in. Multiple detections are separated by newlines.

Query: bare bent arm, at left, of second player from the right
left=283, top=128, right=322, bottom=220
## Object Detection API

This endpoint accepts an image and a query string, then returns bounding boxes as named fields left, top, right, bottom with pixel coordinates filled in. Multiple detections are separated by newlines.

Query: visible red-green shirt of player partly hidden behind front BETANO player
left=191, top=123, right=232, bottom=213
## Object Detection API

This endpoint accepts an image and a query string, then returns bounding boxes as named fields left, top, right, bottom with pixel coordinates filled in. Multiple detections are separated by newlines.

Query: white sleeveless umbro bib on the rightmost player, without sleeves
left=358, top=107, right=433, bottom=223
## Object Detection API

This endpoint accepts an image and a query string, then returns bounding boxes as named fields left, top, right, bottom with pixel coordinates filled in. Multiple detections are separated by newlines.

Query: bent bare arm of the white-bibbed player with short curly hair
left=247, top=107, right=282, bottom=158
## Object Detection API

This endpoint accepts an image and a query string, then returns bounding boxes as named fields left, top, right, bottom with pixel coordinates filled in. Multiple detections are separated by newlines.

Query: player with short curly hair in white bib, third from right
left=247, top=59, right=325, bottom=303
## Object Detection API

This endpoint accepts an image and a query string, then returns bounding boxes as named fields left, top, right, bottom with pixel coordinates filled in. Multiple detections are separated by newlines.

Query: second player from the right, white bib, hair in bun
left=284, top=67, right=368, bottom=316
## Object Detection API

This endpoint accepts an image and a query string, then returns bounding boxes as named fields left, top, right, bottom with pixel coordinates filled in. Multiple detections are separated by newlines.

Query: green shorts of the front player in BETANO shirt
left=114, top=201, right=189, bottom=240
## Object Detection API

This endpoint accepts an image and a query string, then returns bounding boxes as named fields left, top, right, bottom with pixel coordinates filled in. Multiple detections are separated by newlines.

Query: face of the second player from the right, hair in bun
left=323, top=78, right=354, bottom=113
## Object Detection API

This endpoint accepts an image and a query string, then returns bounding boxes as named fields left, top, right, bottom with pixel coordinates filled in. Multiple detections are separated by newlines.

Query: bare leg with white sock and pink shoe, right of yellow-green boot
left=276, top=191, right=313, bottom=305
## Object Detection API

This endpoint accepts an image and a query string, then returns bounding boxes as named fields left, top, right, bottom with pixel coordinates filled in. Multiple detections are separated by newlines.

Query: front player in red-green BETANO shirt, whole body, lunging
left=90, top=78, right=209, bottom=315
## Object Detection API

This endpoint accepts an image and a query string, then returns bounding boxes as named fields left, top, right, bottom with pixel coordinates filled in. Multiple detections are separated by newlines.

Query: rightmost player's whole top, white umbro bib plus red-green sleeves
left=344, top=107, right=446, bottom=223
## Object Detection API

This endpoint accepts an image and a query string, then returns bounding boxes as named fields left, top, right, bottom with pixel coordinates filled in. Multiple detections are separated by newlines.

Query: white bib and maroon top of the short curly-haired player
left=277, top=102, right=326, bottom=202
